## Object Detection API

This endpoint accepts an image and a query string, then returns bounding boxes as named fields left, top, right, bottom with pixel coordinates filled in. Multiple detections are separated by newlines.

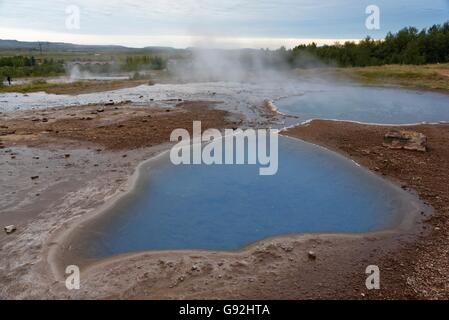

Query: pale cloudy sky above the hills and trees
left=0, top=0, right=449, bottom=48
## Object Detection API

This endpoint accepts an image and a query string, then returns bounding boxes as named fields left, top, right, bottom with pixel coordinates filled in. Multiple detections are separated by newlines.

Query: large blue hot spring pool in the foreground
left=74, top=137, right=415, bottom=258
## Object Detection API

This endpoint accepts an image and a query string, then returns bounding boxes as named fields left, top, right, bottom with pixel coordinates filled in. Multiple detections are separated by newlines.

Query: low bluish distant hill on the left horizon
left=0, top=39, right=178, bottom=53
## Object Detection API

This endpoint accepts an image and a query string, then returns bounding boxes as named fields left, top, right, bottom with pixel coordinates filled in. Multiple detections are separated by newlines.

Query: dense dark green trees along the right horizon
left=288, top=22, right=449, bottom=67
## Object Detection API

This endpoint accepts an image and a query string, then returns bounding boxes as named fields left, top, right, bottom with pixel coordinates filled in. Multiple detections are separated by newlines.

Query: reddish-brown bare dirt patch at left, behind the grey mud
left=0, top=101, right=231, bottom=150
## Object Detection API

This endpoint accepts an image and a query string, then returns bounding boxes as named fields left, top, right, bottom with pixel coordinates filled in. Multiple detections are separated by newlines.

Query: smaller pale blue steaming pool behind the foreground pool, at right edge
left=276, top=86, right=449, bottom=124
